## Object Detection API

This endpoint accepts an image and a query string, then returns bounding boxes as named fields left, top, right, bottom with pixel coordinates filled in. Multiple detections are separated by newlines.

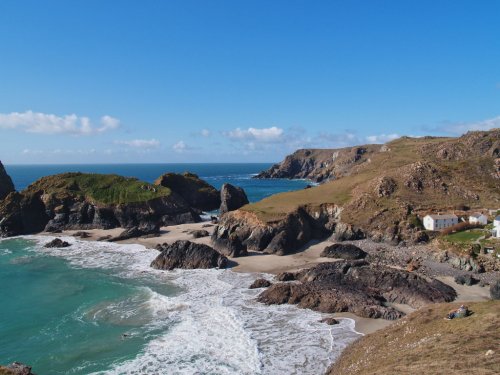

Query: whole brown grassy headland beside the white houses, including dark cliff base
left=214, top=129, right=500, bottom=254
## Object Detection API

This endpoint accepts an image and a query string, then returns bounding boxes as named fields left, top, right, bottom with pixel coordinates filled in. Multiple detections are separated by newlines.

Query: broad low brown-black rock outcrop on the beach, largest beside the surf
left=258, top=261, right=456, bottom=320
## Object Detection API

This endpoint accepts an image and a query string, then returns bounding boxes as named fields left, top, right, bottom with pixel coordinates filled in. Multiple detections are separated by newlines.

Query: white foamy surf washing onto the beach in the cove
left=26, top=237, right=359, bottom=374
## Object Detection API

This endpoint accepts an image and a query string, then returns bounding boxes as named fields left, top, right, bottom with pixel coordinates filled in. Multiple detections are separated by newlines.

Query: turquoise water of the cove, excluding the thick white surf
left=0, top=239, right=179, bottom=374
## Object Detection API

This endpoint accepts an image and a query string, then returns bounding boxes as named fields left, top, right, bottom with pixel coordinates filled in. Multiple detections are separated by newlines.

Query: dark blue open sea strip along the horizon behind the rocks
left=5, top=163, right=309, bottom=202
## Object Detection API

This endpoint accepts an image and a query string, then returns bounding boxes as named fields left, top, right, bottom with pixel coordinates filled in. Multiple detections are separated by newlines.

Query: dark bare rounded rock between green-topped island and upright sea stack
left=155, top=172, right=221, bottom=211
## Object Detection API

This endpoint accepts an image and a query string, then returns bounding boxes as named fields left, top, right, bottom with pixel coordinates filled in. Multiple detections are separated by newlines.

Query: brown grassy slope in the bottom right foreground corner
left=328, top=301, right=500, bottom=375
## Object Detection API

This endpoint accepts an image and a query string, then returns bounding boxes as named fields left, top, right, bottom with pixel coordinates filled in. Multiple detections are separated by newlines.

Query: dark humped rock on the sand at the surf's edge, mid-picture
left=151, top=241, right=227, bottom=270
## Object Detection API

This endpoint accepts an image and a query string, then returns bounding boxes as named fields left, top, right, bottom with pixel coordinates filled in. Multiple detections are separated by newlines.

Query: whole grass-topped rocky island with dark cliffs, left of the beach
left=0, top=173, right=199, bottom=237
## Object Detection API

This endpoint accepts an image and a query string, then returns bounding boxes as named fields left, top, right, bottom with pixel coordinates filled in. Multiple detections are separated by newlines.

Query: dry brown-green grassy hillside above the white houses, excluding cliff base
left=243, top=130, right=500, bottom=226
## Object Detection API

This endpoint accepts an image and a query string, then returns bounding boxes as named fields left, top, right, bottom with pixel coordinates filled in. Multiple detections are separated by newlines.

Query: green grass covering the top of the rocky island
left=23, top=173, right=171, bottom=204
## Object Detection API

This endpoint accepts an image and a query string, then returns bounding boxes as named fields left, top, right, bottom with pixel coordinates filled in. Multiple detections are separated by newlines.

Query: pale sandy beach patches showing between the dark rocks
left=53, top=222, right=489, bottom=334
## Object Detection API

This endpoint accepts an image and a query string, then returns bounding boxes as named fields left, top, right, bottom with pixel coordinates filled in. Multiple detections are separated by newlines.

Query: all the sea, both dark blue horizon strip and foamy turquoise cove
left=0, top=164, right=359, bottom=375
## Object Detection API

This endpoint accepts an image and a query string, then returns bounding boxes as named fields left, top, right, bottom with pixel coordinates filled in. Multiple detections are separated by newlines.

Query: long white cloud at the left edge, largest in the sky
left=0, top=111, right=120, bottom=135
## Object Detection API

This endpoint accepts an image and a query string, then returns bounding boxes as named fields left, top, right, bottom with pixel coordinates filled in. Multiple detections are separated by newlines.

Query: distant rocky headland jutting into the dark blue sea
left=255, top=145, right=381, bottom=182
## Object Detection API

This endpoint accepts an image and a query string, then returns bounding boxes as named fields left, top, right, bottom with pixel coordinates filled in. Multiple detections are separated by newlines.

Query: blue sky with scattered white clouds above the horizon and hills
left=0, top=0, right=500, bottom=164
